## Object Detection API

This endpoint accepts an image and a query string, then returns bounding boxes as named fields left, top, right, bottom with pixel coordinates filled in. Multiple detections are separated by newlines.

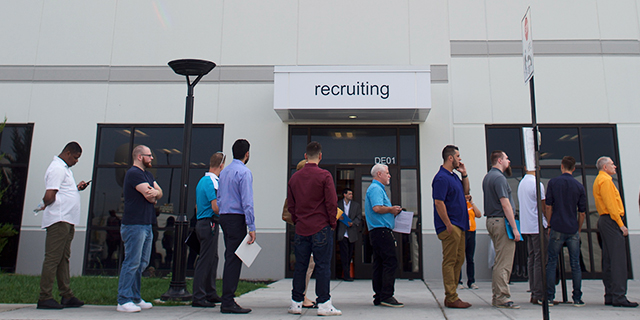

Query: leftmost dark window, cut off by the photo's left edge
left=0, top=124, right=33, bottom=272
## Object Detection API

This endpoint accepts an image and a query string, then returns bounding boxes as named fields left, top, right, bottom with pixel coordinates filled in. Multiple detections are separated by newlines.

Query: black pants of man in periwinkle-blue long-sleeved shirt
left=220, top=214, right=247, bottom=307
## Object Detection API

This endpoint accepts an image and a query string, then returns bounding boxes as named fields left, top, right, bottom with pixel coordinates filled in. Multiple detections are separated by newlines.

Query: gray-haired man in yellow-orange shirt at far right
left=593, top=156, right=638, bottom=308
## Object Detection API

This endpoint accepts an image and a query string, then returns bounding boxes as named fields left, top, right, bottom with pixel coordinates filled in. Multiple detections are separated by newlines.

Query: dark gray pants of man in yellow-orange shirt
left=598, top=214, right=627, bottom=304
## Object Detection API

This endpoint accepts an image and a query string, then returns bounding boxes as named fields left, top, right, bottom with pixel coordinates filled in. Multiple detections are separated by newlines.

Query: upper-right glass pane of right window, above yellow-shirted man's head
left=580, top=127, right=618, bottom=166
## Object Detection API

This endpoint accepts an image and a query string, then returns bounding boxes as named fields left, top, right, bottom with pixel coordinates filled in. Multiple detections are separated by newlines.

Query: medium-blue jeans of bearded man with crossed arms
left=118, top=224, right=153, bottom=304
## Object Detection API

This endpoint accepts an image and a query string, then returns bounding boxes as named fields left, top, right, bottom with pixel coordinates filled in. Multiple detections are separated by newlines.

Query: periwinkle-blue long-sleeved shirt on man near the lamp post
left=218, top=159, right=256, bottom=231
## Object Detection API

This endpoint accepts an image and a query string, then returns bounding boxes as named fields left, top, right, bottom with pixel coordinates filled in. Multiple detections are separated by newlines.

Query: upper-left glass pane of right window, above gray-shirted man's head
left=487, top=128, right=524, bottom=168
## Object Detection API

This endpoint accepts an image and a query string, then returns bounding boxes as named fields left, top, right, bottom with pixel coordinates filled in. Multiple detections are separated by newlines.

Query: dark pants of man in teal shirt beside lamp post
left=193, top=218, right=220, bottom=301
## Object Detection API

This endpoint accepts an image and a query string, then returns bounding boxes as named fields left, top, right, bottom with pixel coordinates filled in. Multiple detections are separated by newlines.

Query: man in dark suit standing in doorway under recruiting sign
left=337, top=188, right=362, bottom=281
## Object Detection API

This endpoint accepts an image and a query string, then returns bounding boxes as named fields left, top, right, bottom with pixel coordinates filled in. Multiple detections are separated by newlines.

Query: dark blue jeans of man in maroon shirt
left=291, top=226, right=333, bottom=304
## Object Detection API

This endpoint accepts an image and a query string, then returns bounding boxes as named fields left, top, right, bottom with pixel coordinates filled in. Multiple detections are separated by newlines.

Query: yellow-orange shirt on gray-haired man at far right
left=593, top=171, right=624, bottom=227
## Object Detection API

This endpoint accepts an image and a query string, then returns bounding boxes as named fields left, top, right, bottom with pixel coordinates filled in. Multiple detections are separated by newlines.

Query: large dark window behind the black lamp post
left=84, top=124, right=223, bottom=274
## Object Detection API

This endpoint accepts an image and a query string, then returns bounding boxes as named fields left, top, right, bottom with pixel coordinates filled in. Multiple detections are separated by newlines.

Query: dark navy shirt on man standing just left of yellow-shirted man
left=546, top=173, right=587, bottom=234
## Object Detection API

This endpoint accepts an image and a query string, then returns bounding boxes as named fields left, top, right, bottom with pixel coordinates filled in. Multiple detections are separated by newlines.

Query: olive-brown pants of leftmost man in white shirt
left=39, top=221, right=75, bottom=301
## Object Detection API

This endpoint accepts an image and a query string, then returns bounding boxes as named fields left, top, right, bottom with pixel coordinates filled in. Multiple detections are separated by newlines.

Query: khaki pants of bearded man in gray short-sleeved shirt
left=487, top=217, right=516, bottom=306
